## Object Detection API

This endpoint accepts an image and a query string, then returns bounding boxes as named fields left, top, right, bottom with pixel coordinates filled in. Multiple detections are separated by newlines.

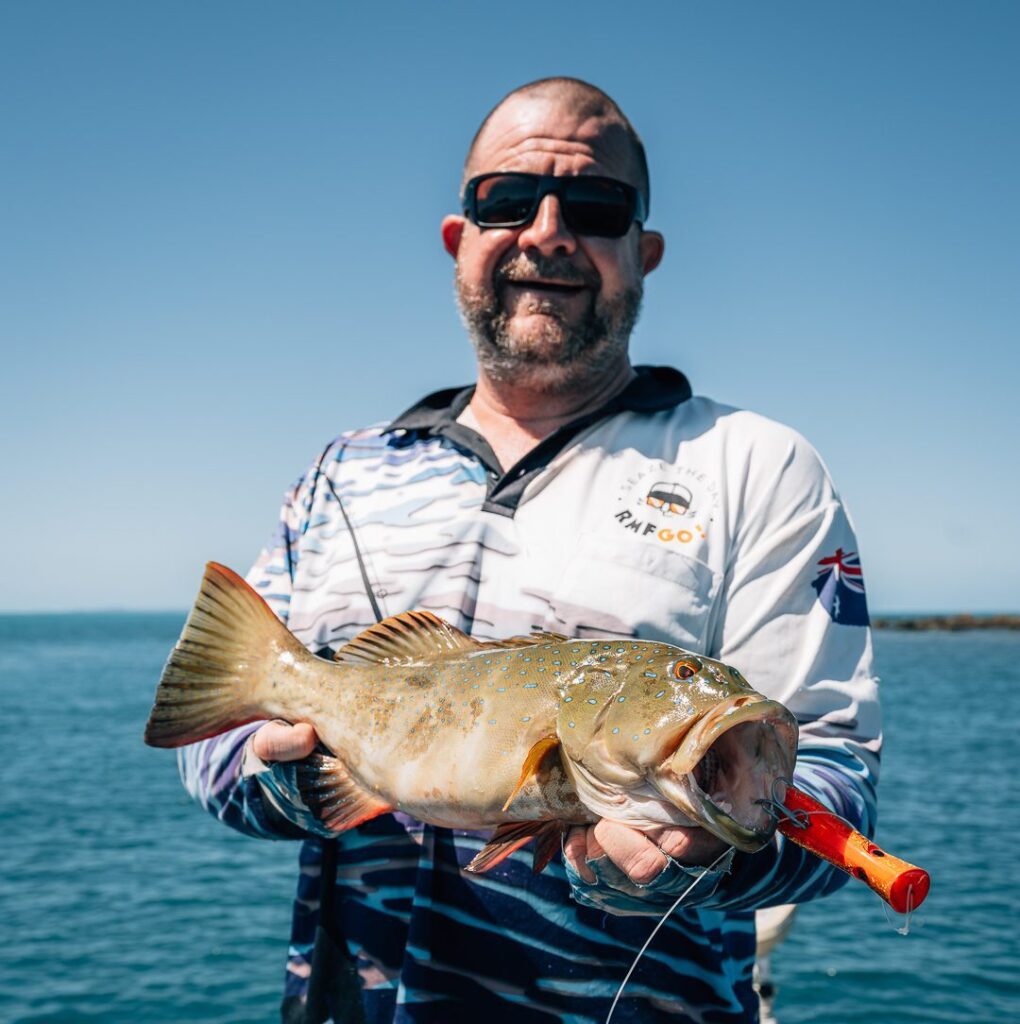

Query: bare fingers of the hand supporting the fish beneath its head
left=563, top=818, right=727, bottom=886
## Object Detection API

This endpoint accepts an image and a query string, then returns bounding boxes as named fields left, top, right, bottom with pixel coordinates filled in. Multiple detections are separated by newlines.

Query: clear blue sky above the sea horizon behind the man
left=0, top=0, right=1020, bottom=610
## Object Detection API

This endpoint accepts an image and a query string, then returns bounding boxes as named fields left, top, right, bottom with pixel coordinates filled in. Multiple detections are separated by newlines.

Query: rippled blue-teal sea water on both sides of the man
left=0, top=614, right=1020, bottom=1024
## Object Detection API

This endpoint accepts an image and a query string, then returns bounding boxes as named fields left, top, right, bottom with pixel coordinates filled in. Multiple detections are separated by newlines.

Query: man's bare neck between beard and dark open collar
left=470, top=355, right=636, bottom=469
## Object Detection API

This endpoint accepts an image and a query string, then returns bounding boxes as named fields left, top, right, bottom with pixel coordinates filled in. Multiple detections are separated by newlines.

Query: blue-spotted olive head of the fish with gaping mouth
left=557, top=641, right=797, bottom=852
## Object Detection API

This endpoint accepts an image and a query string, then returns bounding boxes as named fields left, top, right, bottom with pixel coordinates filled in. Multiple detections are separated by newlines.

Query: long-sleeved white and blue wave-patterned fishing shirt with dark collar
left=180, top=367, right=881, bottom=1024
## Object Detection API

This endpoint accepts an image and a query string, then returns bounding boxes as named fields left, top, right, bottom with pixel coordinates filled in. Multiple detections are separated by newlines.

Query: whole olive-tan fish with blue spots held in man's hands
left=144, top=562, right=798, bottom=871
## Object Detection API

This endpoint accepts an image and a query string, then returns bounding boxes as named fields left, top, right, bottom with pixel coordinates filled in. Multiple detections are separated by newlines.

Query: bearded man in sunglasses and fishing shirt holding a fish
left=182, top=79, right=879, bottom=1024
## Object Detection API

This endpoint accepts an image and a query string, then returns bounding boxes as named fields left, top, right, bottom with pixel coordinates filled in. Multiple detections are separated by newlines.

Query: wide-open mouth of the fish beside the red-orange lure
left=655, top=696, right=797, bottom=853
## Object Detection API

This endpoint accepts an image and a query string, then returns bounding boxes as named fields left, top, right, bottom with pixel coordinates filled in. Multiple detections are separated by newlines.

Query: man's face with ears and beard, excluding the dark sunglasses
left=442, top=96, right=663, bottom=391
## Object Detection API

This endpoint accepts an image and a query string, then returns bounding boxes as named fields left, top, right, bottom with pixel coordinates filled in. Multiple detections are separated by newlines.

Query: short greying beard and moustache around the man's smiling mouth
left=457, top=254, right=642, bottom=393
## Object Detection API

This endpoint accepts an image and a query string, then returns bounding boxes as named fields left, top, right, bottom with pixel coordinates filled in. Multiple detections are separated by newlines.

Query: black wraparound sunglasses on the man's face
left=464, top=171, right=648, bottom=239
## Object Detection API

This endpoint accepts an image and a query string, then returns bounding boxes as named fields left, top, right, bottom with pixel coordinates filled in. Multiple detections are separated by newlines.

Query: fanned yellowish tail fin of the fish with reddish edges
left=145, top=562, right=307, bottom=746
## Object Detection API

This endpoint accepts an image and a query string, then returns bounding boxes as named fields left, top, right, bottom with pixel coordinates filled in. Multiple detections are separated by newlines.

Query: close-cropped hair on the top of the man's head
left=464, top=78, right=649, bottom=209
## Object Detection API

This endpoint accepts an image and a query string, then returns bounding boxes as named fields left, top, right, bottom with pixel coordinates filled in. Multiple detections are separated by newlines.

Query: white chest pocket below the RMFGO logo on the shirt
left=546, top=534, right=721, bottom=651
